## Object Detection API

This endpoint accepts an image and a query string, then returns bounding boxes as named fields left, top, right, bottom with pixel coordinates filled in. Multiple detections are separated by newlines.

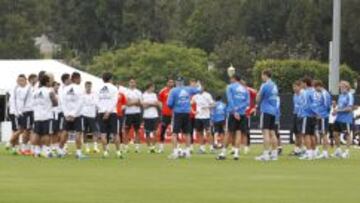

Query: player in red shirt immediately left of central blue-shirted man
left=158, top=79, right=175, bottom=153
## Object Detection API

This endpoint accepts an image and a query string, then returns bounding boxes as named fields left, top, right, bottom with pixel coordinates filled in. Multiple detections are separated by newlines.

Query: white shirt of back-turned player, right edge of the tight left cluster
left=60, top=84, right=84, bottom=117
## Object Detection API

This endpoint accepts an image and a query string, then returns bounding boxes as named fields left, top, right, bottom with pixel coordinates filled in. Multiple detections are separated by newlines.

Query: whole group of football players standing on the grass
left=4, top=70, right=354, bottom=161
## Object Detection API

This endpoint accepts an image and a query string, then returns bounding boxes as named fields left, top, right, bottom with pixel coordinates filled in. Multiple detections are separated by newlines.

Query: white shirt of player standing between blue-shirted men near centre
left=193, top=91, right=215, bottom=119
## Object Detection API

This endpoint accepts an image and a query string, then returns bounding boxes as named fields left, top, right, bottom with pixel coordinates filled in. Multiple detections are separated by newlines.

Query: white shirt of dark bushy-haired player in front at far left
left=33, top=87, right=53, bottom=121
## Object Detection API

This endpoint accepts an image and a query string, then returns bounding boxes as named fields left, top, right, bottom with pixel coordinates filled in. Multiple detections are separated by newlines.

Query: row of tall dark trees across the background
left=0, top=0, right=360, bottom=84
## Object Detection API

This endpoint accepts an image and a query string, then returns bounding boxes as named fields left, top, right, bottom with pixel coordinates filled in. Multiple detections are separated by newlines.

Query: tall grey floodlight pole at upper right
left=329, top=0, right=341, bottom=95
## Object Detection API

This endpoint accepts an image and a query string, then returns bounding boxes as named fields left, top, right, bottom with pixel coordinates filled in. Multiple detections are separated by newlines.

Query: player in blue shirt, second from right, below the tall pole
left=313, top=80, right=331, bottom=159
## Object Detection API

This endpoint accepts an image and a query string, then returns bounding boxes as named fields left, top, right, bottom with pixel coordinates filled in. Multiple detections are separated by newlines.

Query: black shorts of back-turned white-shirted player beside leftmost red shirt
left=98, top=113, right=121, bottom=135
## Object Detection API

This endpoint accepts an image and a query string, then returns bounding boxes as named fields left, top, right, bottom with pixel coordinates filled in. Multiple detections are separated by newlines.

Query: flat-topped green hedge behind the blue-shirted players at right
left=253, top=60, right=358, bottom=93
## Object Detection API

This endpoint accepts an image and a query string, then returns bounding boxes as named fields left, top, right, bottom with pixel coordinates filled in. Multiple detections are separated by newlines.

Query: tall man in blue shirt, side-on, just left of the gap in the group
left=255, top=70, right=278, bottom=161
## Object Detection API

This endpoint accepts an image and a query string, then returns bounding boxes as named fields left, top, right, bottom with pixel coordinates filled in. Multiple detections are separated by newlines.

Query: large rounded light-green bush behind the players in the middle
left=88, top=41, right=225, bottom=93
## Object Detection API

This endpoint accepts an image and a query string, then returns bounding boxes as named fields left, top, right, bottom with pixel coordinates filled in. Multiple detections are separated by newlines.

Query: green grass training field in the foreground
left=0, top=146, right=360, bottom=203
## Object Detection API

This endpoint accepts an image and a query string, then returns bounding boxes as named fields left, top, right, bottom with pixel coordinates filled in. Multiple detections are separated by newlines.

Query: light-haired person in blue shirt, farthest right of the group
left=333, top=81, right=354, bottom=158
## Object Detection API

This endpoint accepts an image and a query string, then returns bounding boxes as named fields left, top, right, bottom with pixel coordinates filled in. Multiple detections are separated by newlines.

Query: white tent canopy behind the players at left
left=0, top=59, right=102, bottom=93
